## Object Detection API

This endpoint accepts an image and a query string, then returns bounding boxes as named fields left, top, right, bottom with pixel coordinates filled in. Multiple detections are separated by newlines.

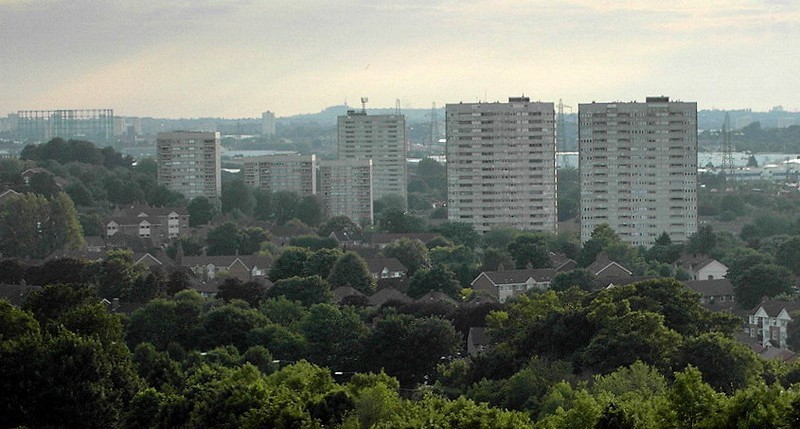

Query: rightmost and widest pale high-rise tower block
left=578, top=97, right=697, bottom=246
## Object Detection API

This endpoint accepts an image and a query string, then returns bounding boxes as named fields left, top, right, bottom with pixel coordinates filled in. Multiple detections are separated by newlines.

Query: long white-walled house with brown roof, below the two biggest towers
left=471, top=268, right=556, bottom=302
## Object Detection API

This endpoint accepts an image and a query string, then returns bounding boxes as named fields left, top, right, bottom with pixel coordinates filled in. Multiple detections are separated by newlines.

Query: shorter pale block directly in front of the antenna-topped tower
left=318, top=159, right=373, bottom=224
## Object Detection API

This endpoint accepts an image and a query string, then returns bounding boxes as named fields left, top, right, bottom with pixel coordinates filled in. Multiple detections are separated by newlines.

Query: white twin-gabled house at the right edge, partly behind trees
left=748, top=300, right=800, bottom=349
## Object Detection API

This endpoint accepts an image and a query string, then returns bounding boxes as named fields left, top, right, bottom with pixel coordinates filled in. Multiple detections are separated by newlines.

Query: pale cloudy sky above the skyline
left=0, top=0, right=800, bottom=118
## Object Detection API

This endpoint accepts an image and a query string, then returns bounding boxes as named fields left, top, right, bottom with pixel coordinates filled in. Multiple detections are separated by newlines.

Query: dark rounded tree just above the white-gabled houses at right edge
left=733, top=264, right=792, bottom=308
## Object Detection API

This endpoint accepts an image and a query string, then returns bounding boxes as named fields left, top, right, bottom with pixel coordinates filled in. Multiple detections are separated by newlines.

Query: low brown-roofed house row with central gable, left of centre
left=180, top=255, right=272, bottom=281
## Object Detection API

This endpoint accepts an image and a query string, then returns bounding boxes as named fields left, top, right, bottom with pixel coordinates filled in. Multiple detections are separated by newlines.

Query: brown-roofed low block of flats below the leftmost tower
left=105, top=206, right=189, bottom=246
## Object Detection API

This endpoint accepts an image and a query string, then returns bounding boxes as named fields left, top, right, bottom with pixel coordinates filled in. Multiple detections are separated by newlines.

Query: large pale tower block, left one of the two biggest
left=445, top=97, right=557, bottom=233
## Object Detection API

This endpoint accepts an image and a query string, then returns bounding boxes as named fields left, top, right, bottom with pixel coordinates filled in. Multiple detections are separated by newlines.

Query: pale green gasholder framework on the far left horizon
left=14, top=109, right=114, bottom=143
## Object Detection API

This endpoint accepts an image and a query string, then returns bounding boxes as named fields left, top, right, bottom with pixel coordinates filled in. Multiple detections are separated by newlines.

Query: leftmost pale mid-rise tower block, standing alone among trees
left=156, top=131, right=222, bottom=203
